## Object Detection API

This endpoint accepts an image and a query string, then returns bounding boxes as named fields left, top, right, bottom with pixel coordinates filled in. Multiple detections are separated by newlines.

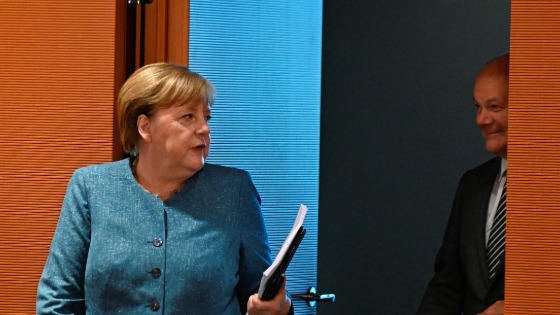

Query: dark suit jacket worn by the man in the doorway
left=417, top=158, right=504, bottom=315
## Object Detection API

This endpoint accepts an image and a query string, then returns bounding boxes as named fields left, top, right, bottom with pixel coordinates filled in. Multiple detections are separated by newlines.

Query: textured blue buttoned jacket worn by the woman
left=37, top=159, right=271, bottom=315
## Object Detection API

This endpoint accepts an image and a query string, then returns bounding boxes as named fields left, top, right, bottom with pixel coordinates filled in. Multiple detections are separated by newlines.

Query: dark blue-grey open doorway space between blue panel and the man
left=318, top=0, right=510, bottom=315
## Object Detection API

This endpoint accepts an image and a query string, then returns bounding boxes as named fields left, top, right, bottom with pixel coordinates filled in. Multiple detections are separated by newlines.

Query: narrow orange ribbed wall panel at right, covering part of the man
left=506, top=0, right=560, bottom=315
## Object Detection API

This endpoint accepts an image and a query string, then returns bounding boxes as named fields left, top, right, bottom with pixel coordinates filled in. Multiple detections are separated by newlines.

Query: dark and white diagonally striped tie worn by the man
left=486, top=174, right=507, bottom=280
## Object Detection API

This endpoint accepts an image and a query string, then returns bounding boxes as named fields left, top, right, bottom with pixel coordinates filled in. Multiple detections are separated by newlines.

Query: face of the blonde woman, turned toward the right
left=147, top=102, right=210, bottom=176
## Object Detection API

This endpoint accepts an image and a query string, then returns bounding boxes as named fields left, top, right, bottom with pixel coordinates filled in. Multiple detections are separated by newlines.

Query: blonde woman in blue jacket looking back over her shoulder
left=37, top=63, right=293, bottom=315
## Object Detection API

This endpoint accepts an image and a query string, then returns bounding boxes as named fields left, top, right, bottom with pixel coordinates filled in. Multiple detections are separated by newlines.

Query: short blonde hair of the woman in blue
left=117, top=62, right=215, bottom=153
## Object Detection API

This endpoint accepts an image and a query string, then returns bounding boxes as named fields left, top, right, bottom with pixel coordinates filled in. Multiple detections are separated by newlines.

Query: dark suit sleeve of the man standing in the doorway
left=417, top=180, right=464, bottom=315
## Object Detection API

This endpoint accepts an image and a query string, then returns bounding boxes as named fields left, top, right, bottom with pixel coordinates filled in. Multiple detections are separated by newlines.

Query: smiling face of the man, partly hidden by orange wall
left=474, top=73, right=508, bottom=159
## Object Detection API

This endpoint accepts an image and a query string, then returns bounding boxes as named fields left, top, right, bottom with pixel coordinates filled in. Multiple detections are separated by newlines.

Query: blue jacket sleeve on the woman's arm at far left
left=36, top=170, right=90, bottom=314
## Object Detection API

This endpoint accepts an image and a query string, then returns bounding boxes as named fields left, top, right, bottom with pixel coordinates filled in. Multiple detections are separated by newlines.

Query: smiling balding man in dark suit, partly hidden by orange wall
left=417, top=54, right=509, bottom=315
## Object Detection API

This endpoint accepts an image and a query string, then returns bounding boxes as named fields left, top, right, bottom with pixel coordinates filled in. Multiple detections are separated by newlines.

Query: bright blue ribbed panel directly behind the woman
left=189, top=0, right=322, bottom=315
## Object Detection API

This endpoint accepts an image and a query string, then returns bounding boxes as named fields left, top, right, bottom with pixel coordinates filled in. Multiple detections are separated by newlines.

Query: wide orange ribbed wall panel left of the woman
left=0, top=0, right=116, bottom=314
